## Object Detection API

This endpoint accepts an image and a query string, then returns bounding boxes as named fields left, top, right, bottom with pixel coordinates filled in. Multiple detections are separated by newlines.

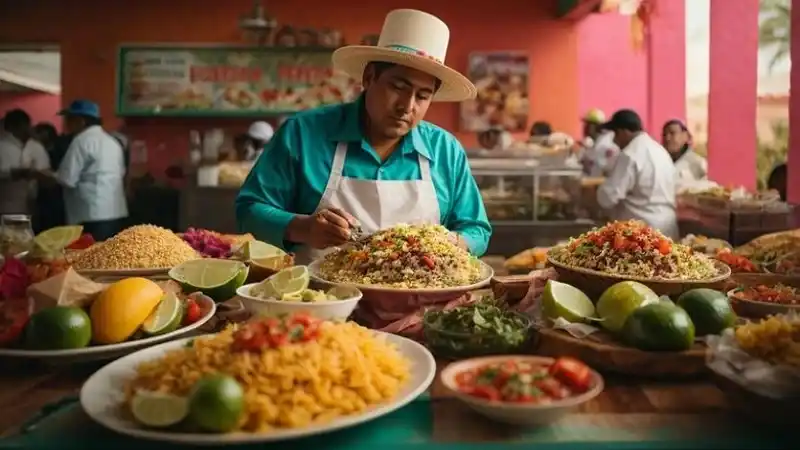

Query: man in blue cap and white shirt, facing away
left=35, top=100, right=128, bottom=241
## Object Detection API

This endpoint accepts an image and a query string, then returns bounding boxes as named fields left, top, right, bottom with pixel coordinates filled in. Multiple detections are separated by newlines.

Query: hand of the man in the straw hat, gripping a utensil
left=287, top=208, right=358, bottom=249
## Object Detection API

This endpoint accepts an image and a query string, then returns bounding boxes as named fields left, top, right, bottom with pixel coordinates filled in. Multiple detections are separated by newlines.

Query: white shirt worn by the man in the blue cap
left=57, top=125, right=128, bottom=224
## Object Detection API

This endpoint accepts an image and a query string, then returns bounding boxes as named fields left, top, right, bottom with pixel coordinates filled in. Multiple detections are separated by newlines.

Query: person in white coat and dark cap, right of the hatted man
left=597, top=109, right=679, bottom=239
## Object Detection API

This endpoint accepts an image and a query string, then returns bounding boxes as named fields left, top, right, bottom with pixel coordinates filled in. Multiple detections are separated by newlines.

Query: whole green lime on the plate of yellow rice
left=189, top=375, right=244, bottom=433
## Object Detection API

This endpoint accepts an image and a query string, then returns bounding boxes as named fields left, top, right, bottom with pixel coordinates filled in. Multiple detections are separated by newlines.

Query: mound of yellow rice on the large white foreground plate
left=125, top=322, right=411, bottom=432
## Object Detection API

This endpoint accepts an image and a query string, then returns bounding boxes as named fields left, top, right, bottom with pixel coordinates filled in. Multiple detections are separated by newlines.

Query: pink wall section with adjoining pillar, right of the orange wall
left=578, top=1, right=686, bottom=135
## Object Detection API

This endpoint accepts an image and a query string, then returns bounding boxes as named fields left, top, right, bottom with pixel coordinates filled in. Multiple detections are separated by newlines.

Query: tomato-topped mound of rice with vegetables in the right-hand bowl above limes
left=549, top=220, right=719, bottom=280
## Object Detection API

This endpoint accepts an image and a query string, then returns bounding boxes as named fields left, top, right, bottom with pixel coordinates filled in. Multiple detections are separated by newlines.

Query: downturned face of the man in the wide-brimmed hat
left=363, top=65, right=437, bottom=139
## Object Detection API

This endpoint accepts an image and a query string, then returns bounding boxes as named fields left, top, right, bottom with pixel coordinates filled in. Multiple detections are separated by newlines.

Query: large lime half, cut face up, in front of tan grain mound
left=169, top=258, right=248, bottom=302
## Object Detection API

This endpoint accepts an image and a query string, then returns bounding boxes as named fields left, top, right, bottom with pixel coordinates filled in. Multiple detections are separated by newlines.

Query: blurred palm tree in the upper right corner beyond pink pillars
left=758, top=0, right=792, bottom=70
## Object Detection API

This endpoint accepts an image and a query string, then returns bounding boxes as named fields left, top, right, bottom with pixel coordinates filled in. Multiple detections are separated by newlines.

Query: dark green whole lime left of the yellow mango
left=25, top=306, right=92, bottom=350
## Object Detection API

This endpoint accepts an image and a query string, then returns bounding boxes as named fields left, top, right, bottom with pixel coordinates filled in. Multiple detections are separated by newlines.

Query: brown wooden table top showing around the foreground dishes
left=0, top=361, right=764, bottom=443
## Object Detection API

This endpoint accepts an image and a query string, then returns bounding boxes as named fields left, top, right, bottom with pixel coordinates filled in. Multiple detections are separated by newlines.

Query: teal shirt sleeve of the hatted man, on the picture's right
left=444, top=141, right=492, bottom=256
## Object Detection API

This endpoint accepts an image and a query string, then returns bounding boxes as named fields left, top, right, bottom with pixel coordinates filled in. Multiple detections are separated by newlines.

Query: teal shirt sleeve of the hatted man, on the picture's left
left=236, top=119, right=300, bottom=251
